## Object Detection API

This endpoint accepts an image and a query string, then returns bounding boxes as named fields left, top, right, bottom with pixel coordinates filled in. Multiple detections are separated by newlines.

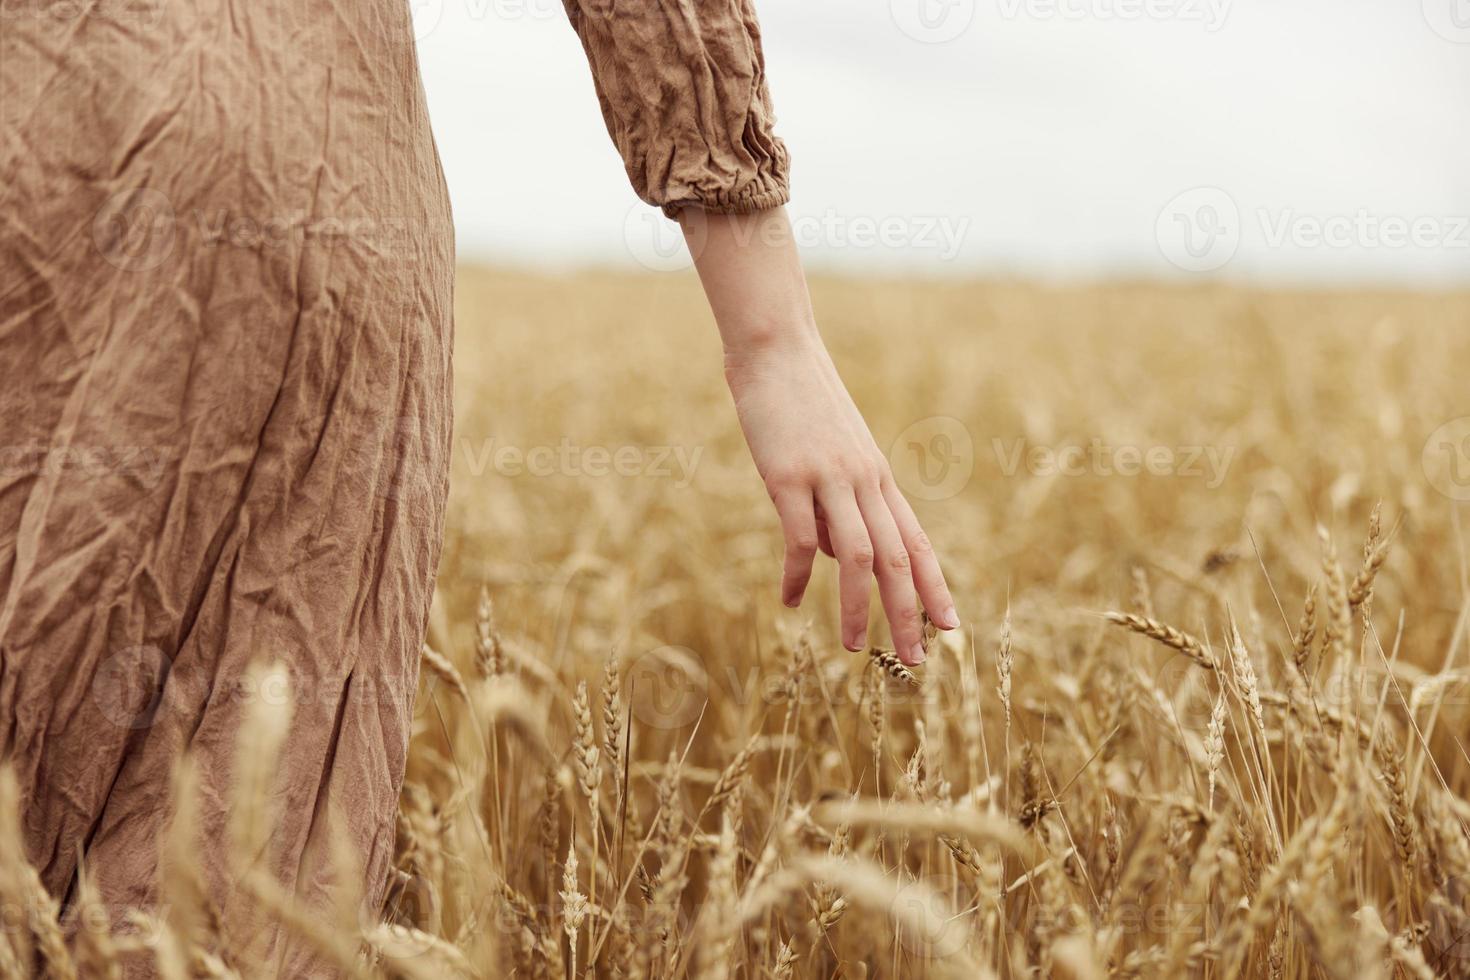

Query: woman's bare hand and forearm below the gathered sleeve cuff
left=681, top=209, right=958, bottom=664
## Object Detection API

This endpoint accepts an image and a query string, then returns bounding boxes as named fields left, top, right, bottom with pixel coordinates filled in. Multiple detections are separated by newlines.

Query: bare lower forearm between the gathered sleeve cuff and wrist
left=679, top=207, right=820, bottom=357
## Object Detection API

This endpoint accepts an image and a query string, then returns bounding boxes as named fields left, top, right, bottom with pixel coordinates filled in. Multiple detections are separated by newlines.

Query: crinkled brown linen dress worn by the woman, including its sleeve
left=0, top=0, right=786, bottom=976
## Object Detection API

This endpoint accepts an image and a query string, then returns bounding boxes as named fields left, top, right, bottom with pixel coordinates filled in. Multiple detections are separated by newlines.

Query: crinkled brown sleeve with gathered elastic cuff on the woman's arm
left=563, top=0, right=789, bottom=217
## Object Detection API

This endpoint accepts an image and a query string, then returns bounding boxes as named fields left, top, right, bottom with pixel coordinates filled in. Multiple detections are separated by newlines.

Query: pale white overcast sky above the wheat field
left=415, top=0, right=1470, bottom=285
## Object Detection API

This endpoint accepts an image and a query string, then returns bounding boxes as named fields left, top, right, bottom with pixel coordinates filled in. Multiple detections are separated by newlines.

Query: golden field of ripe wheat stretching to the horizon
left=0, top=269, right=1470, bottom=980
